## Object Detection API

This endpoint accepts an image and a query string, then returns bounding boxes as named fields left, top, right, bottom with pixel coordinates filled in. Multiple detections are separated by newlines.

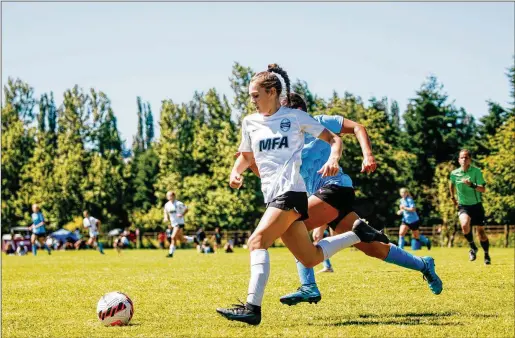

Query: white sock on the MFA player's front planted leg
left=247, top=249, right=270, bottom=306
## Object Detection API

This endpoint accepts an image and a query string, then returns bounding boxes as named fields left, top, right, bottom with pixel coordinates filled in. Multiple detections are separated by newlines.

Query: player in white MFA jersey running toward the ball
left=217, top=64, right=388, bottom=325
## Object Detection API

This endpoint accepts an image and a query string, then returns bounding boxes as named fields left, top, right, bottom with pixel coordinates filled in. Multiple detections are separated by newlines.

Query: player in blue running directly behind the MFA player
left=247, top=93, right=443, bottom=305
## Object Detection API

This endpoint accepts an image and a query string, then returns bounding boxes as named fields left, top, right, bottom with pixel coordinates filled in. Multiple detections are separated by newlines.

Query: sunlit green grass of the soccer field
left=2, top=248, right=514, bottom=337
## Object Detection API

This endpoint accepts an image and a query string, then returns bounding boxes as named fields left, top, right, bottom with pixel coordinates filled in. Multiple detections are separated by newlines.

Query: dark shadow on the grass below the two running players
left=313, top=312, right=466, bottom=326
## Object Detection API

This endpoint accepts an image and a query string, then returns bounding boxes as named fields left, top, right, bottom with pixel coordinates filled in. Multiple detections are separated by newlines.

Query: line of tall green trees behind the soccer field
left=1, top=59, right=515, bottom=231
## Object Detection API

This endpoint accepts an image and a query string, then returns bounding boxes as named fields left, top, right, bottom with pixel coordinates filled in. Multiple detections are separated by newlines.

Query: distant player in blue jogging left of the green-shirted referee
left=397, top=188, right=431, bottom=250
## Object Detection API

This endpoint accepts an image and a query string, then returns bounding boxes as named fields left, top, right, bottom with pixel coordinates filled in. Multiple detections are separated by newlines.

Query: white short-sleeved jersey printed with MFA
left=238, top=107, right=324, bottom=203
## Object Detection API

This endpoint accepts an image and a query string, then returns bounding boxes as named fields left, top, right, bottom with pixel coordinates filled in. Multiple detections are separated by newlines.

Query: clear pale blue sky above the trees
left=2, top=2, right=515, bottom=145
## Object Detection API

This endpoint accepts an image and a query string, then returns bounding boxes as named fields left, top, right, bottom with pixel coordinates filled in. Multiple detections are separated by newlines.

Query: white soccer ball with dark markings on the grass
left=97, top=291, right=134, bottom=326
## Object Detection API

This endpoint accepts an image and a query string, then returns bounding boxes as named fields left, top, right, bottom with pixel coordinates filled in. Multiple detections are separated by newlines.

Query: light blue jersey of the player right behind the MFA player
left=300, top=115, right=352, bottom=195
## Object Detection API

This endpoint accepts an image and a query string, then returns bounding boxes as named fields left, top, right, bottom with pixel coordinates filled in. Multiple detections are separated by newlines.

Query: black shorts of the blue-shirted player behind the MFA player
left=313, top=184, right=356, bottom=230
